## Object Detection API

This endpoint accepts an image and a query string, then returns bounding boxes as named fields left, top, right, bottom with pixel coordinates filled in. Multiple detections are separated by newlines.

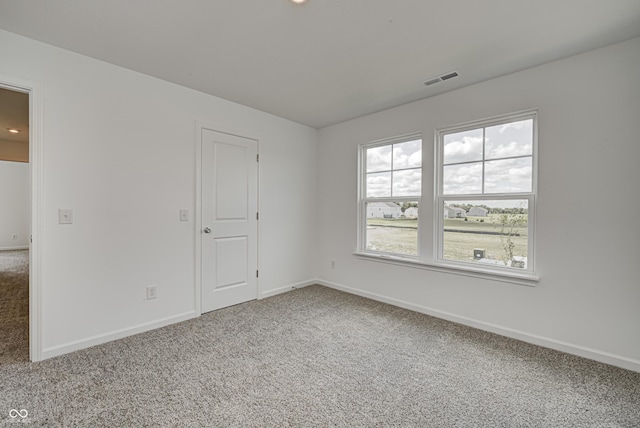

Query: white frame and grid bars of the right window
left=433, top=110, right=538, bottom=281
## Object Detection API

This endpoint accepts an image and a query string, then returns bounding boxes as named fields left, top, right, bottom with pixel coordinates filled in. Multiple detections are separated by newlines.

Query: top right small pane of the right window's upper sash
left=485, top=119, right=533, bottom=159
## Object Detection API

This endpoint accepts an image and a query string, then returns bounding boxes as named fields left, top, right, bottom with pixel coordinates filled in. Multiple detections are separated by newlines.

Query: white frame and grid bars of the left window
left=356, top=133, right=425, bottom=261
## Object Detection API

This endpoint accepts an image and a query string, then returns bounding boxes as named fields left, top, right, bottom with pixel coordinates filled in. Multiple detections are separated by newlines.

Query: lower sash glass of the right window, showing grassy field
left=442, top=199, right=529, bottom=269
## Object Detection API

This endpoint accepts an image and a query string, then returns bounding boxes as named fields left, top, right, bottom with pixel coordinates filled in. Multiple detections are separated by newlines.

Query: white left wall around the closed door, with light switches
left=0, top=31, right=317, bottom=357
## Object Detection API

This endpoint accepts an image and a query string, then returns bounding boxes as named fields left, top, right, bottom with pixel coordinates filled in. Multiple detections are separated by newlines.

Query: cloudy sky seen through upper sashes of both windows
left=366, top=119, right=533, bottom=197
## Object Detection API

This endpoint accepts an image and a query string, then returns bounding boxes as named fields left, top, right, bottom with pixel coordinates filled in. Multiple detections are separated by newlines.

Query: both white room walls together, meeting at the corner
left=0, top=27, right=640, bottom=370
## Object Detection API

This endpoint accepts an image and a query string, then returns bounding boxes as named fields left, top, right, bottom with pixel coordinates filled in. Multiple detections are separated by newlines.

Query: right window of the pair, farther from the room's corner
left=436, top=112, right=536, bottom=273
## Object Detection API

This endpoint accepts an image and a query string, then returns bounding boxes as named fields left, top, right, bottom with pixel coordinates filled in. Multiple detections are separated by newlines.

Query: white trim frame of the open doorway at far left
left=0, top=75, right=44, bottom=361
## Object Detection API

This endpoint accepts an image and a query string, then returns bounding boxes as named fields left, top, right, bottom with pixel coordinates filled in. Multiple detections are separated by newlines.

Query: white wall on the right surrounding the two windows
left=318, top=39, right=640, bottom=371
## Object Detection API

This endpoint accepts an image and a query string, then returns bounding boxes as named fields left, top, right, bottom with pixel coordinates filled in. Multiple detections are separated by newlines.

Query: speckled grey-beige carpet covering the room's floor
left=0, top=249, right=640, bottom=428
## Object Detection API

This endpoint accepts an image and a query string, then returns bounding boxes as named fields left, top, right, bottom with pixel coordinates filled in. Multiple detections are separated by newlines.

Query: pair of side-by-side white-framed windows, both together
left=356, top=111, right=537, bottom=283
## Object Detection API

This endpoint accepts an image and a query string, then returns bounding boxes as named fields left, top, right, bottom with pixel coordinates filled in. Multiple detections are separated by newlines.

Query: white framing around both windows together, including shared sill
left=354, top=109, right=540, bottom=286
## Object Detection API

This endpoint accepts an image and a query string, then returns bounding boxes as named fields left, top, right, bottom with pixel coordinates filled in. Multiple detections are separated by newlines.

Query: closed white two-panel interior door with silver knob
left=200, top=129, right=258, bottom=313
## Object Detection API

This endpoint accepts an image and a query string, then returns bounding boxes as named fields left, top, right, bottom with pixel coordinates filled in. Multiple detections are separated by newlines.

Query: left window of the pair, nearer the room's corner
left=359, top=135, right=422, bottom=257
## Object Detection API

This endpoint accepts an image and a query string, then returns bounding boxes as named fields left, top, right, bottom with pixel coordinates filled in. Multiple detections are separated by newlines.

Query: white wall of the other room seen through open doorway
left=0, top=161, right=31, bottom=247
